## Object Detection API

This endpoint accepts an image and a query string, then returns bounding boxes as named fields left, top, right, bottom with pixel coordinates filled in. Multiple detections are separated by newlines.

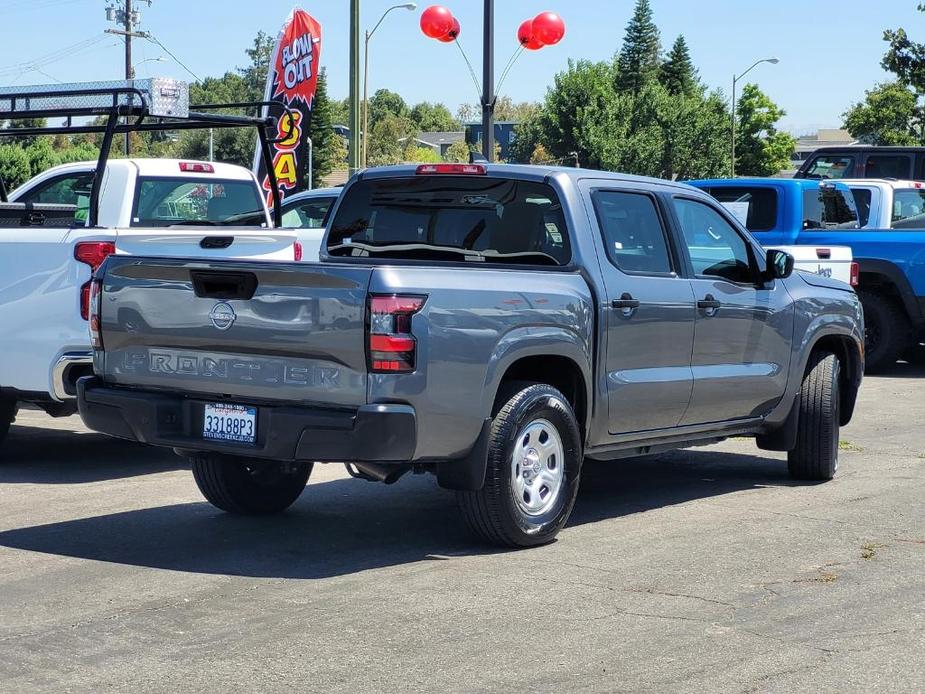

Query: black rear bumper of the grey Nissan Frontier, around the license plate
left=77, top=377, right=417, bottom=463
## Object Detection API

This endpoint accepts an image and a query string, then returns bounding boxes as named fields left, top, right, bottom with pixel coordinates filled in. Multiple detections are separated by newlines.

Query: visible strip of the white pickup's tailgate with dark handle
left=116, top=227, right=298, bottom=261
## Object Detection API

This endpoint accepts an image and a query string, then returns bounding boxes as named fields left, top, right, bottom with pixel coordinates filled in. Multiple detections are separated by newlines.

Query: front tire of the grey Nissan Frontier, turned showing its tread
left=787, top=352, right=840, bottom=481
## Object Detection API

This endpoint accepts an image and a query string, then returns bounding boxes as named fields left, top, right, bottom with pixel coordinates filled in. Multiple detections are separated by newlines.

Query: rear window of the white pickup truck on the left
left=132, top=178, right=267, bottom=227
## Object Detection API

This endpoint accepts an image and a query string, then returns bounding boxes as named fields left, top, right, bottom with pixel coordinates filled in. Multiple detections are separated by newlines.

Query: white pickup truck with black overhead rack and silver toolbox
left=0, top=79, right=301, bottom=440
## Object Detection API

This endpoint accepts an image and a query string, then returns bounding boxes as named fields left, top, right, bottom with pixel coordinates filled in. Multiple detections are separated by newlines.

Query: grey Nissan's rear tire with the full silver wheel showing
left=457, top=384, right=582, bottom=547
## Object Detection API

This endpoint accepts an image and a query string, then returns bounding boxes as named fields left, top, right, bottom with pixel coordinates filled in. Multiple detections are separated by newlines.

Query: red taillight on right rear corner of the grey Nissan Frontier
left=369, top=296, right=426, bottom=373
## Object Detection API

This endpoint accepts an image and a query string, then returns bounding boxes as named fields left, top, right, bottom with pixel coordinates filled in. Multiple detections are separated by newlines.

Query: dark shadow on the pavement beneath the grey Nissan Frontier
left=0, top=451, right=790, bottom=579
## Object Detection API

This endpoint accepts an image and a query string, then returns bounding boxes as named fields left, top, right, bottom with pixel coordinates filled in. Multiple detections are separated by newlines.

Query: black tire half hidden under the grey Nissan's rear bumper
left=189, top=453, right=312, bottom=515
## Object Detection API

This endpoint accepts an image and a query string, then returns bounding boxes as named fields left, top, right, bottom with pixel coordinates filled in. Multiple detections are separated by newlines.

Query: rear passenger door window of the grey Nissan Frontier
left=592, top=190, right=672, bottom=275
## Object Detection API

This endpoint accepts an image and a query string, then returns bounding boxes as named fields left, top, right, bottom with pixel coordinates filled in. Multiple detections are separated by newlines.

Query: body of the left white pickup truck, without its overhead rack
left=0, top=159, right=296, bottom=435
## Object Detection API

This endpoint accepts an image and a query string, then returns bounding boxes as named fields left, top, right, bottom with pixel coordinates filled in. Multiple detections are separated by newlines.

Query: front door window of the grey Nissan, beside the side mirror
left=674, top=198, right=755, bottom=284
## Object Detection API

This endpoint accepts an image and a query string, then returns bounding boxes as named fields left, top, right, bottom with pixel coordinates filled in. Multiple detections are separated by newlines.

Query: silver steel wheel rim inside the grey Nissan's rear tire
left=511, top=419, right=565, bottom=516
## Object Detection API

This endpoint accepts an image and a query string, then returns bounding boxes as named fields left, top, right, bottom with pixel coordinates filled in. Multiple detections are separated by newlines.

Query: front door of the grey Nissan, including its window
left=672, top=196, right=793, bottom=426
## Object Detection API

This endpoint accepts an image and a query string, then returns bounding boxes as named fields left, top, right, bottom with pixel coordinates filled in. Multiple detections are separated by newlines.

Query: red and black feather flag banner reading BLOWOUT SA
left=254, top=9, right=321, bottom=205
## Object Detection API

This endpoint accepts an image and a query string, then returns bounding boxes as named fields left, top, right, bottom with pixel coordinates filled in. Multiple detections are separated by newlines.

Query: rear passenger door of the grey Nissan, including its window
left=589, top=187, right=695, bottom=434
